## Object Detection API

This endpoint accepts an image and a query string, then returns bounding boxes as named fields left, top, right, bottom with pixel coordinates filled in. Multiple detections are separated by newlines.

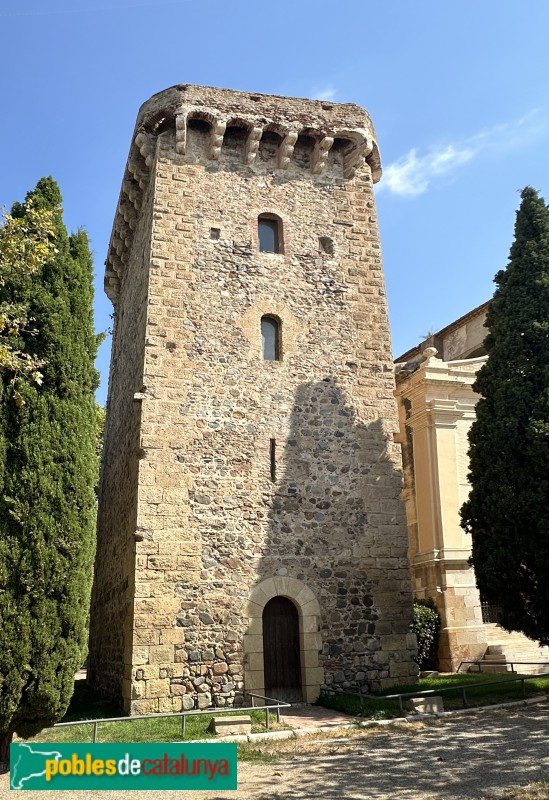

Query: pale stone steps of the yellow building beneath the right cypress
left=474, top=624, right=549, bottom=675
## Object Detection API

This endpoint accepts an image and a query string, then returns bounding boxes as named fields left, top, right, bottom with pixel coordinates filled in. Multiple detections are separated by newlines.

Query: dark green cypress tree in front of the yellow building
left=462, top=188, right=549, bottom=645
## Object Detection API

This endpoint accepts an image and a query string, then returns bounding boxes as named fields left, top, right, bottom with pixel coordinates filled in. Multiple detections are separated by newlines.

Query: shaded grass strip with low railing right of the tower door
left=319, top=673, right=549, bottom=720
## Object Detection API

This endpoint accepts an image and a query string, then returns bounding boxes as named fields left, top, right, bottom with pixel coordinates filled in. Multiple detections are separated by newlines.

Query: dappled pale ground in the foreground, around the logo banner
left=0, top=703, right=549, bottom=800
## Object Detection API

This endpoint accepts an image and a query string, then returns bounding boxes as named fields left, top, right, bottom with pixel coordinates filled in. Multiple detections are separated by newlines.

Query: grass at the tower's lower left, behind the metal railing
left=23, top=681, right=284, bottom=748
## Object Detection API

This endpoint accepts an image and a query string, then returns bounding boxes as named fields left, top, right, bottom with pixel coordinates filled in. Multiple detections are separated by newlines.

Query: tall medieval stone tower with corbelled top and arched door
left=89, top=85, right=416, bottom=713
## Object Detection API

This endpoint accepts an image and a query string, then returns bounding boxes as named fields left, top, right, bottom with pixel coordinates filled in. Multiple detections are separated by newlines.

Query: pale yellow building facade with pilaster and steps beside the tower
left=396, top=303, right=549, bottom=672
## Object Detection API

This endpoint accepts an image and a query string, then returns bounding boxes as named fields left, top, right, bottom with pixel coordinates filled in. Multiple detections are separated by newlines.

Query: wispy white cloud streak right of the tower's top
left=379, top=110, right=545, bottom=197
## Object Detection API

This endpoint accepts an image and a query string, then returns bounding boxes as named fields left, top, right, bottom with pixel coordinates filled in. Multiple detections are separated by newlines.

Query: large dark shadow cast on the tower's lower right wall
left=253, top=376, right=415, bottom=692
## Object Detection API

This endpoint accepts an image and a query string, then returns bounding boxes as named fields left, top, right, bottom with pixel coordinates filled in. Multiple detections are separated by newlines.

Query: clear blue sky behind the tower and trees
left=0, top=0, right=549, bottom=400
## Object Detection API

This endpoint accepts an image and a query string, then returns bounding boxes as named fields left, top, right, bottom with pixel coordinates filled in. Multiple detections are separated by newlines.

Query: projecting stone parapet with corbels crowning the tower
left=105, top=84, right=381, bottom=303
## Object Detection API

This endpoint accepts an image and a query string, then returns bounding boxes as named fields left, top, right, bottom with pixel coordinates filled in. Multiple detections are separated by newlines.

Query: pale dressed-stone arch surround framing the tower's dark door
left=243, top=575, right=324, bottom=703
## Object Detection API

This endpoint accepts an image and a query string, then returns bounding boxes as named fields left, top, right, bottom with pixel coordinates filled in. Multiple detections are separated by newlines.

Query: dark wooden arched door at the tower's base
left=263, top=595, right=303, bottom=703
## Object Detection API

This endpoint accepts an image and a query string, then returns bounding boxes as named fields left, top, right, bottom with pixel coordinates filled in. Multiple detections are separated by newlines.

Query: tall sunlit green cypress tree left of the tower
left=0, top=178, right=97, bottom=768
